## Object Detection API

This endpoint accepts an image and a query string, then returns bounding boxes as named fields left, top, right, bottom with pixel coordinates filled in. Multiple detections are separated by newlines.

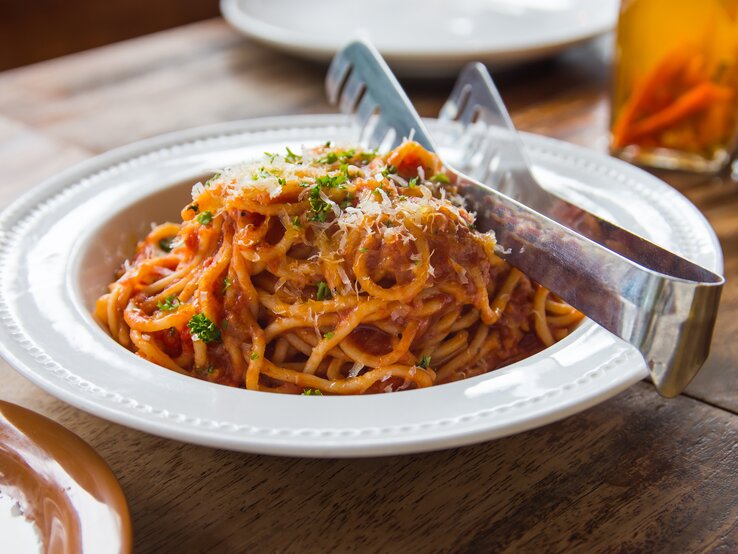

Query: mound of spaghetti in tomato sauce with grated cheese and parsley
left=95, top=141, right=582, bottom=394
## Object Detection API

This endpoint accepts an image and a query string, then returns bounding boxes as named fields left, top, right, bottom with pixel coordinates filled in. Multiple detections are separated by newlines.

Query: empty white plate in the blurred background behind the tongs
left=220, top=0, right=620, bottom=76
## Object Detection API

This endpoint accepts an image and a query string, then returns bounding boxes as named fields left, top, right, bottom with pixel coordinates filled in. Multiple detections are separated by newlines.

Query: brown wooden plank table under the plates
left=0, top=20, right=738, bottom=552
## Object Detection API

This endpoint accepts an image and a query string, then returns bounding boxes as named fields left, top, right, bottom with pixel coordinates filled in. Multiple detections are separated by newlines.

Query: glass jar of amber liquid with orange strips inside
left=610, top=0, right=738, bottom=172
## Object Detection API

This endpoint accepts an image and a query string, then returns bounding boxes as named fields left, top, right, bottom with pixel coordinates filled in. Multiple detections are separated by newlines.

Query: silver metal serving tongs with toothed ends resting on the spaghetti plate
left=326, top=41, right=724, bottom=397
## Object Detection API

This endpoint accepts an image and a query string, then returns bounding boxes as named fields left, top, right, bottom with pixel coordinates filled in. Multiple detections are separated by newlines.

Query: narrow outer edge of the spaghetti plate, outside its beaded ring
left=0, top=115, right=722, bottom=457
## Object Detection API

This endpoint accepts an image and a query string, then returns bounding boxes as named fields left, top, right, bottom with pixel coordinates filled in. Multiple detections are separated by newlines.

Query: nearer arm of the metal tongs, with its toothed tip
left=326, top=41, right=724, bottom=397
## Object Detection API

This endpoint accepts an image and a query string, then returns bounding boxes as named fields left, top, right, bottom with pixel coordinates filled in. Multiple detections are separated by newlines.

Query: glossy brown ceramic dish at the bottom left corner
left=0, top=401, right=132, bottom=554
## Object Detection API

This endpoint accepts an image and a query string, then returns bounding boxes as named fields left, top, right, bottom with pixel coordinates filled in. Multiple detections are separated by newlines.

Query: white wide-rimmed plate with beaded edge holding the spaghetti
left=0, top=116, right=722, bottom=456
